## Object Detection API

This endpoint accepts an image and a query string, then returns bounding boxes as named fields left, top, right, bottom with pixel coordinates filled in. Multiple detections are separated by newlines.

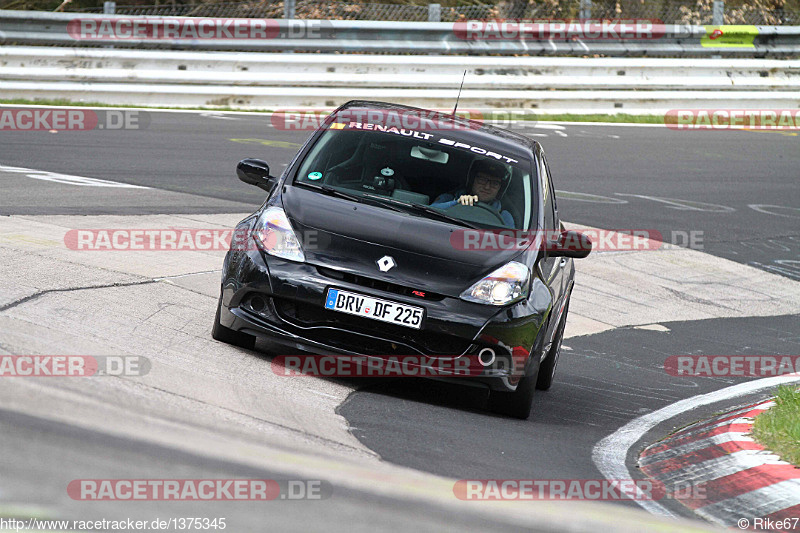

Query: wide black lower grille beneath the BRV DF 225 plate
left=273, top=298, right=472, bottom=355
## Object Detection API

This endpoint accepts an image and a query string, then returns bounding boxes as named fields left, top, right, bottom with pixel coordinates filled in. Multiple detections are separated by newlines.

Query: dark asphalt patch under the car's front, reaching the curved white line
left=340, top=315, right=800, bottom=517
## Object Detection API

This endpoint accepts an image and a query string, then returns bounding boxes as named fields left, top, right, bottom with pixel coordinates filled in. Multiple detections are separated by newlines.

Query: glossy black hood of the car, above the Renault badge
left=282, top=186, right=532, bottom=297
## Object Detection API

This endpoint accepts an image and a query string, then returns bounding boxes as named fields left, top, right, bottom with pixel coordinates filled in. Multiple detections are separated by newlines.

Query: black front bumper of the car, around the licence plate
left=220, top=245, right=547, bottom=391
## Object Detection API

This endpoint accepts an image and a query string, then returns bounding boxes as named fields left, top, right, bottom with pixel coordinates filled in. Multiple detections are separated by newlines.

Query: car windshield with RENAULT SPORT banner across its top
left=294, top=122, right=536, bottom=230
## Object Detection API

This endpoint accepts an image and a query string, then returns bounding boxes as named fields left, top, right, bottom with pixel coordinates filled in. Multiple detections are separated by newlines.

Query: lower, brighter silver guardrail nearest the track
left=0, top=46, right=800, bottom=114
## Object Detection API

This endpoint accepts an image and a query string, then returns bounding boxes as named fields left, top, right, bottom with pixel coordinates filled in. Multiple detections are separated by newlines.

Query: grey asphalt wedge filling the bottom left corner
left=0, top=410, right=515, bottom=533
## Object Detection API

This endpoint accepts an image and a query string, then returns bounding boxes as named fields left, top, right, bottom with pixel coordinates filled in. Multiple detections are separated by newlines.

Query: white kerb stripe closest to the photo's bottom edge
left=696, top=479, right=800, bottom=525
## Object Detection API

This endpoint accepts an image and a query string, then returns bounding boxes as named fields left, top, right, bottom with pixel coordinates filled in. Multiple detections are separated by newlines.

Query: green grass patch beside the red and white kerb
left=752, top=385, right=800, bottom=466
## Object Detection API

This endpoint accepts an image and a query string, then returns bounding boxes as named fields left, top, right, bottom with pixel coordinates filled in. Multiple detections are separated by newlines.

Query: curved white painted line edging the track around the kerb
left=592, top=376, right=800, bottom=517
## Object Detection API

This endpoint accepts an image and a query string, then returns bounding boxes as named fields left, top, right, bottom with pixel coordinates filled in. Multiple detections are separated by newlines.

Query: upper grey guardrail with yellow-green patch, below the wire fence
left=0, top=11, right=800, bottom=57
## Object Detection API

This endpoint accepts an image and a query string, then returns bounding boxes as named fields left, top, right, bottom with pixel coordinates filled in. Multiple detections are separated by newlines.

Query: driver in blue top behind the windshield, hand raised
left=431, top=159, right=514, bottom=227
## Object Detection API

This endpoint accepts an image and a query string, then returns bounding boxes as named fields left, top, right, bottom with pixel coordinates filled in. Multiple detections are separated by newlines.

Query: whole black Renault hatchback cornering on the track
left=212, top=101, right=591, bottom=418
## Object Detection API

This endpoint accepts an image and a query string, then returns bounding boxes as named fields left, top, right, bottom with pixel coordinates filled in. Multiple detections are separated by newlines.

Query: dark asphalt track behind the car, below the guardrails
left=0, top=111, right=800, bottom=279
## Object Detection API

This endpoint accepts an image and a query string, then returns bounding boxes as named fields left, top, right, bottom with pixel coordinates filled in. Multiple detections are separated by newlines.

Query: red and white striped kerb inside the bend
left=639, top=400, right=800, bottom=531
